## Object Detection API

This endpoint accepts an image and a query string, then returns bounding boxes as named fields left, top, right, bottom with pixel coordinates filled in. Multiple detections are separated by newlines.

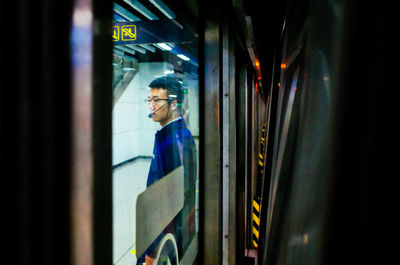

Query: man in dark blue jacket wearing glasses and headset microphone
left=139, top=75, right=197, bottom=265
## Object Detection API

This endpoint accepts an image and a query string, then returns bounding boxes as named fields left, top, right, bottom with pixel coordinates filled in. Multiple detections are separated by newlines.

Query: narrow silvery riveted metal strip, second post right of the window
left=222, top=21, right=237, bottom=265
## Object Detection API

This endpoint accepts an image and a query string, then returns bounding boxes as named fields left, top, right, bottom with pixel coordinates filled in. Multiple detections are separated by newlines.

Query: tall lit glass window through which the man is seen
left=112, top=0, right=199, bottom=265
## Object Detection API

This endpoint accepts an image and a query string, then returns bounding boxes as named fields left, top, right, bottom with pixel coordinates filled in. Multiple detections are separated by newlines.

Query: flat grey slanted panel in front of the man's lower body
left=136, top=166, right=184, bottom=257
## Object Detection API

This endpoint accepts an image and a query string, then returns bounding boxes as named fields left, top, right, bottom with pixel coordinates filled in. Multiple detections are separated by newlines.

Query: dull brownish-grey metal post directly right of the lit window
left=202, top=17, right=221, bottom=264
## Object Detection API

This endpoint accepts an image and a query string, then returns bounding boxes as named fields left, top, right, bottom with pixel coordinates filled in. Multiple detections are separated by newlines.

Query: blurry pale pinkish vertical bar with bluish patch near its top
left=71, top=0, right=94, bottom=265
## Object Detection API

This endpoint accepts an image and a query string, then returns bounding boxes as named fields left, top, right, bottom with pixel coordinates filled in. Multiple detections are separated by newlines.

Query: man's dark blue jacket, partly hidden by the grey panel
left=138, top=118, right=197, bottom=262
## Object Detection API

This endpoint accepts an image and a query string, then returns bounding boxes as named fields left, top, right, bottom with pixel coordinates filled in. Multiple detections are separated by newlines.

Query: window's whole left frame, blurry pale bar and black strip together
left=71, top=0, right=112, bottom=265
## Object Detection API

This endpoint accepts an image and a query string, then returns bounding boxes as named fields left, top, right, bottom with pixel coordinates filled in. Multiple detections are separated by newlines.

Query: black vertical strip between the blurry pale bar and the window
left=92, top=0, right=113, bottom=265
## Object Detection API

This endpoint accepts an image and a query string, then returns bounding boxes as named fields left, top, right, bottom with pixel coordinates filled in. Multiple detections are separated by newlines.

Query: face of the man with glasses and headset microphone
left=148, top=88, right=172, bottom=126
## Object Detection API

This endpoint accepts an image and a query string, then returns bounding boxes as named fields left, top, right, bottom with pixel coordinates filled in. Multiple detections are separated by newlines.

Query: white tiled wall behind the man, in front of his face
left=113, top=63, right=167, bottom=165
